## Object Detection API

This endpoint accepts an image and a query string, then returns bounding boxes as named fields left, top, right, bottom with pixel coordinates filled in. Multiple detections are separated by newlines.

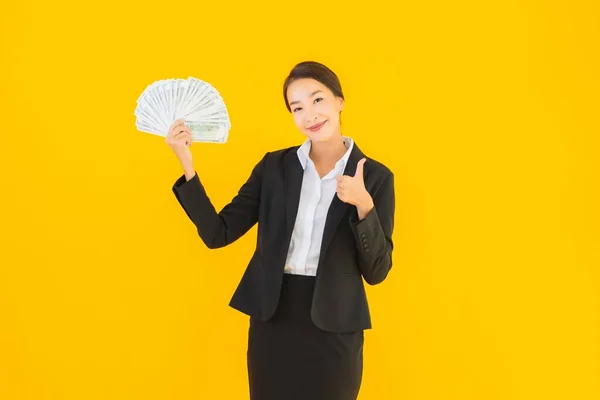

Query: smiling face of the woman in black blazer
left=287, top=78, right=344, bottom=142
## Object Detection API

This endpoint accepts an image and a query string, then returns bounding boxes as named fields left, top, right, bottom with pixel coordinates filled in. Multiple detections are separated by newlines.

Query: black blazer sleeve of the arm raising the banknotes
left=172, top=153, right=269, bottom=249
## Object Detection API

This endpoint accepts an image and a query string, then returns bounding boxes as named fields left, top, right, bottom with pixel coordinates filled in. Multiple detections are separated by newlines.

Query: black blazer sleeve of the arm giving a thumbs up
left=350, top=172, right=396, bottom=285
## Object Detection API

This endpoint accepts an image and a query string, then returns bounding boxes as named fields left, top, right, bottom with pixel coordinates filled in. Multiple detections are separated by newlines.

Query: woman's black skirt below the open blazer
left=247, top=274, right=364, bottom=400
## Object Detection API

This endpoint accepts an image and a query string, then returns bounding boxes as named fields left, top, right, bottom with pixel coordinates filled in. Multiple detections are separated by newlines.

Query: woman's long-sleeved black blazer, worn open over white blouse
left=172, top=143, right=395, bottom=332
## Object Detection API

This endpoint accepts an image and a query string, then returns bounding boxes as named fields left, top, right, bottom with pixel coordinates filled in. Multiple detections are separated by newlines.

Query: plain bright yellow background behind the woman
left=0, top=0, right=600, bottom=400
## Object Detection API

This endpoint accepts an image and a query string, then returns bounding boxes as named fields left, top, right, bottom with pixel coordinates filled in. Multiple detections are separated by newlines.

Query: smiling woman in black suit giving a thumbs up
left=166, top=62, right=395, bottom=400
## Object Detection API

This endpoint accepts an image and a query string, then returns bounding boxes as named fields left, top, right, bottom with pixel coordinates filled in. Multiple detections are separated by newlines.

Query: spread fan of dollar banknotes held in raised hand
left=134, top=77, right=231, bottom=143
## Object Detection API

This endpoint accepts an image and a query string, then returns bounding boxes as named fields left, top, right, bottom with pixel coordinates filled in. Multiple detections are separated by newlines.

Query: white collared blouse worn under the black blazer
left=284, top=136, right=354, bottom=276
